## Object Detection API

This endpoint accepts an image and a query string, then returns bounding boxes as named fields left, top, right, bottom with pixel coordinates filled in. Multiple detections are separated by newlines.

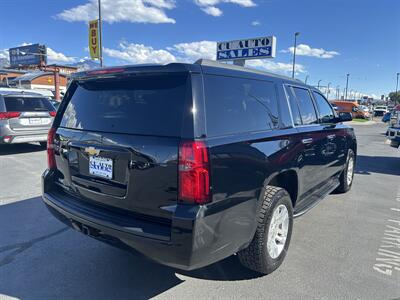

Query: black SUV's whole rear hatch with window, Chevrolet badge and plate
left=55, top=73, right=191, bottom=223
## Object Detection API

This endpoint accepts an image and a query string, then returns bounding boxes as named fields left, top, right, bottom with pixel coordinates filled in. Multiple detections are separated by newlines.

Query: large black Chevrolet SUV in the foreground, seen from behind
left=43, top=60, right=357, bottom=273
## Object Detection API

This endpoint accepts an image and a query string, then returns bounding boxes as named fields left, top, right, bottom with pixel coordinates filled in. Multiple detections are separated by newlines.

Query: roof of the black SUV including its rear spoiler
left=71, top=59, right=304, bottom=88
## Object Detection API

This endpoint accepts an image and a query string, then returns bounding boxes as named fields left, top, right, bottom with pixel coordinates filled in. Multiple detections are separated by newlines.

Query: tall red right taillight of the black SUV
left=179, top=141, right=210, bottom=204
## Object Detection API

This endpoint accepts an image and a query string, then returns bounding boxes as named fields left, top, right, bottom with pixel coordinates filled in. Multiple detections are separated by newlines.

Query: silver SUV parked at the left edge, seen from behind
left=0, top=90, right=56, bottom=147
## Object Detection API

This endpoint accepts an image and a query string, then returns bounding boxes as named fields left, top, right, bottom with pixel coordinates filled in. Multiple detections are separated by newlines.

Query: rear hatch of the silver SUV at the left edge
left=4, top=95, right=55, bottom=131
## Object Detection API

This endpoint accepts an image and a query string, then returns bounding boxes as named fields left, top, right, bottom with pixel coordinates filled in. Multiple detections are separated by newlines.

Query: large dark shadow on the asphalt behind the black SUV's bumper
left=0, top=197, right=260, bottom=299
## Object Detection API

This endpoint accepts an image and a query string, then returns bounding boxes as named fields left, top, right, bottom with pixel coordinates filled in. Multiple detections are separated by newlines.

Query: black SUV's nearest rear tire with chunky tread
left=238, top=186, right=293, bottom=274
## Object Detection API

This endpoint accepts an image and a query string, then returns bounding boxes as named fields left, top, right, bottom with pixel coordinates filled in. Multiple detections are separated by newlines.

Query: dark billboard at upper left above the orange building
left=8, top=44, right=47, bottom=67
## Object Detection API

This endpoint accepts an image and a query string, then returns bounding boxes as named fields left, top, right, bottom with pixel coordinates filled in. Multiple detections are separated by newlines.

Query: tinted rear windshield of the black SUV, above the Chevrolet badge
left=60, top=74, right=187, bottom=136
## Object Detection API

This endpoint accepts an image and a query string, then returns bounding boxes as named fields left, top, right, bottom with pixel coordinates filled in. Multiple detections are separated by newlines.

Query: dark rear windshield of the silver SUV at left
left=4, top=97, right=54, bottom=112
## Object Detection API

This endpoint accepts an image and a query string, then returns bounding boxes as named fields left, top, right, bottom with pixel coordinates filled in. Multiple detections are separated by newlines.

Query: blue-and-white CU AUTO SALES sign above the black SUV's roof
left=217, top=36, right=276, bottom=60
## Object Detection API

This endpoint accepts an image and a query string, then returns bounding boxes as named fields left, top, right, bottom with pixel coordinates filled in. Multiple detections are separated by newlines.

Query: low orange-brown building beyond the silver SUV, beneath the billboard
left=9, top=71, right=67, bottom=93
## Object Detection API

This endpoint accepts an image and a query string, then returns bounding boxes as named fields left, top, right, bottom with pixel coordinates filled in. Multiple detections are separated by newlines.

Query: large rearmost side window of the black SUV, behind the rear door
left=204, top=75, right=279, bottom=136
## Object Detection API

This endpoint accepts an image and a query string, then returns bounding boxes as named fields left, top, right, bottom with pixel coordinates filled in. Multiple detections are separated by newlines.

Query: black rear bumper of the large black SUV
left=42, top=171, right=253, bottom=270
